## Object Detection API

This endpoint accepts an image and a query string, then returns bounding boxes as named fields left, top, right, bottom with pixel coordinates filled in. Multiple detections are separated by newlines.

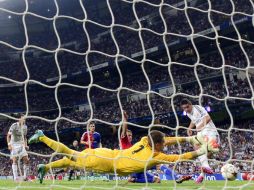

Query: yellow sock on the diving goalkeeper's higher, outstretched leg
left=39, top=135, right=75, bottom=158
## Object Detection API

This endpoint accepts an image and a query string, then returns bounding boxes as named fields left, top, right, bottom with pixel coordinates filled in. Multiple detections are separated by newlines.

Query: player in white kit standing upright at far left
left=7, top=116, right=29, bottom=181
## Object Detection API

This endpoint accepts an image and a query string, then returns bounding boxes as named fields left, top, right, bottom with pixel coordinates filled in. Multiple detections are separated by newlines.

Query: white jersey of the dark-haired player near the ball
left=187, top=105, right=216, bottom=130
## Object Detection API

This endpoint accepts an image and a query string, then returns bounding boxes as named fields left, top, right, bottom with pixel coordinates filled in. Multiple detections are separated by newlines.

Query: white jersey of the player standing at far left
left=8, top=122, right=27, bottom=144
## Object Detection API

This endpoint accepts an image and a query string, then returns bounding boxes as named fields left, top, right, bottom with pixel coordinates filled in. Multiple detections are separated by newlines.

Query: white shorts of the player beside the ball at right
left=197, top=127, right=220, bottom=145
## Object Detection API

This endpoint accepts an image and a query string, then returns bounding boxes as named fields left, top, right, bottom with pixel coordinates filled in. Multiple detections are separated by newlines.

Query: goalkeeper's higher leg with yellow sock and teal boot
left=28, top=130, right=77, bottom=160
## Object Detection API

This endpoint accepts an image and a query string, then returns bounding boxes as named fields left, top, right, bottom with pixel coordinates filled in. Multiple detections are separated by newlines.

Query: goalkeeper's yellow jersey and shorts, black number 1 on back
left=76, top=137, right=192, bottom=175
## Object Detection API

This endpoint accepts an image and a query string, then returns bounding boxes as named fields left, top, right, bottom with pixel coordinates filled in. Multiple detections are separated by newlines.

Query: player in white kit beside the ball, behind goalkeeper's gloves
left=181, top=99, right=220, bottom=183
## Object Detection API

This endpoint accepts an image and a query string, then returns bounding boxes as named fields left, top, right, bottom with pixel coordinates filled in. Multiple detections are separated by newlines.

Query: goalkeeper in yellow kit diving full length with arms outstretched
left=28, top=130, right=218, bottom=183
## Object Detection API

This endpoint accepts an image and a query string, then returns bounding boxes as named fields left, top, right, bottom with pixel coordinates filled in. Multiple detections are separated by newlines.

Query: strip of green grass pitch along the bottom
left=0, top=180, right=254, bottom=190
